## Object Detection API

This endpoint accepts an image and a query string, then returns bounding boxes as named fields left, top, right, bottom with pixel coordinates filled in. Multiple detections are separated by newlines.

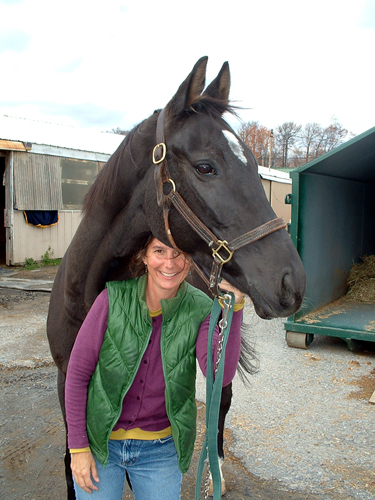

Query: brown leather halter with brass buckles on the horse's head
left=152, top=109, right=286, bottom=297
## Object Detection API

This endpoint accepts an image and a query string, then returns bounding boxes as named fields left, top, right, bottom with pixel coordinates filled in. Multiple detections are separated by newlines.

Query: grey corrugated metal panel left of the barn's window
left=14, top=152, right=63, bottom=210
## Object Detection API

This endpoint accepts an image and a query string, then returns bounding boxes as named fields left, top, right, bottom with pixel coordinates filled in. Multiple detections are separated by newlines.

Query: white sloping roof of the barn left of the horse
left=0, top=115, right=124, bottom=155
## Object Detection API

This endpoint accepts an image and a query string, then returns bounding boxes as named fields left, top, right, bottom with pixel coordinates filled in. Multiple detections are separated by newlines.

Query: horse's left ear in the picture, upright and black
left=167, top=56, right=208, bottom=115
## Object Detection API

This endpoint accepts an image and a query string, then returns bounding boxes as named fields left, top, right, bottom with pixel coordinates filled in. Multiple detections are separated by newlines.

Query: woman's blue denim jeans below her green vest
left=74, top=436, right=182, bottom=500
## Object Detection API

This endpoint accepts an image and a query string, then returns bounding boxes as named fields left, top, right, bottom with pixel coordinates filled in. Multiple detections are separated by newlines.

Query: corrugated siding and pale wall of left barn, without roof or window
left=6, top=152, right=104, bottom=265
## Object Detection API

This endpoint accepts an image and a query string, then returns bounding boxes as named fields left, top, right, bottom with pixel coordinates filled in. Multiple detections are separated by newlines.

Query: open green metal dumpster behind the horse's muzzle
left=284, top=127, right=375, bottom=348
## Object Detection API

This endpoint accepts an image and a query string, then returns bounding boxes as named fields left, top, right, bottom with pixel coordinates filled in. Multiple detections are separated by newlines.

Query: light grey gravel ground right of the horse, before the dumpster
left=198, top=305, right=375, bottom=500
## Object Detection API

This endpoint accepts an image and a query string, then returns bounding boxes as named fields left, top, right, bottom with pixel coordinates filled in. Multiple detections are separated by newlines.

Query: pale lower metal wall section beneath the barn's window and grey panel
left=12, top=210, right=81, bottom=264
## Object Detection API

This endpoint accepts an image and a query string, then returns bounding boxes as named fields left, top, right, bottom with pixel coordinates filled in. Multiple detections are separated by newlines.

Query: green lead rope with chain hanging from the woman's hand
left=195, top=293, right=234, bottom=500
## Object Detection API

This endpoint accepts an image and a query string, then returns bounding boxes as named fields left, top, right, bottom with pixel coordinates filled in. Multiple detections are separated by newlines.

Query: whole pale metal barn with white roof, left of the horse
left=0, top=116, right=124, bottom=265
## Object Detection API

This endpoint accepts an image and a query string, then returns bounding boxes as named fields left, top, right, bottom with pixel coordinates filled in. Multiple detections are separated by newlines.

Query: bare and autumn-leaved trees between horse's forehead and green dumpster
left=238, top=119, right=354, bottom=168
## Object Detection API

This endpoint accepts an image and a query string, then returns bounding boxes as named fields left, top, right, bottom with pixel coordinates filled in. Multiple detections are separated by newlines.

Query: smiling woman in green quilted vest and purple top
left=65, top=237, right=244, bottom=500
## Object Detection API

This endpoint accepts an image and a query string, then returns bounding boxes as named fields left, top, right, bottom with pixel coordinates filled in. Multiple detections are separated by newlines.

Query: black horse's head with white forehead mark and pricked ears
left=145, top=58, right=305, bottom=318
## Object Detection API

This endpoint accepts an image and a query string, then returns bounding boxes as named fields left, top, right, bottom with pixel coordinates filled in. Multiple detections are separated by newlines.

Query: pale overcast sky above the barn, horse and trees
left=0, top=0, right=375, bottom=134
